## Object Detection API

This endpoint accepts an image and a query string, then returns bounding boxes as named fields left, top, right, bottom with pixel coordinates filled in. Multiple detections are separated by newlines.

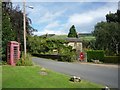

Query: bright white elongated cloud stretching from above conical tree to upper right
left=68, top=4, right=117, bottom=25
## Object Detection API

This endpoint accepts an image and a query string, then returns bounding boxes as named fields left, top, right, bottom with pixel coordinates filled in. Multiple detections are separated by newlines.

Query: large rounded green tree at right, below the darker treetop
left=94, top=22, right=120, bottom=54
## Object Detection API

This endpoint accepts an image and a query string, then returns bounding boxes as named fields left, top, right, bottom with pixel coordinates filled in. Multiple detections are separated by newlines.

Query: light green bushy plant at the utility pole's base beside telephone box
left=16, top=53, right=33, bottom=66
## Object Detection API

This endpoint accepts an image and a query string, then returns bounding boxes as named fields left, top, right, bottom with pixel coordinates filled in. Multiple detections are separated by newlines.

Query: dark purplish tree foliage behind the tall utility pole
left=10, top=6, right=36, bottom=44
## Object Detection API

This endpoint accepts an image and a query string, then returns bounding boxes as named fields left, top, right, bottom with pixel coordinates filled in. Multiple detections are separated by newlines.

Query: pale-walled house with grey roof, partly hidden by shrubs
left=66, top=38, right=82, bottom=52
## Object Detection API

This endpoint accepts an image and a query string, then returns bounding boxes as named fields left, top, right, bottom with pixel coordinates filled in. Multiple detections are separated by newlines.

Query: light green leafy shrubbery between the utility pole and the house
left=27, top=36, right=67, bottom=54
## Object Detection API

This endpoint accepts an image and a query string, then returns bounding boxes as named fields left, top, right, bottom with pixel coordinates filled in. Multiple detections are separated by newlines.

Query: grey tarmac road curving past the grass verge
left=33, top=57, right=118, bottom=88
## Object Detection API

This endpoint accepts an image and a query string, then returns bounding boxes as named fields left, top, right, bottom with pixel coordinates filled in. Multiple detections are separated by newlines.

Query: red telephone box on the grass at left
left=7, top=41, right=20, bottom=66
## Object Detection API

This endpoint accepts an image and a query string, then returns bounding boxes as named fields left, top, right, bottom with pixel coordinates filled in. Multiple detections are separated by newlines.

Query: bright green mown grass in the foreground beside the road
left=2, top=65, right=103, bottom=89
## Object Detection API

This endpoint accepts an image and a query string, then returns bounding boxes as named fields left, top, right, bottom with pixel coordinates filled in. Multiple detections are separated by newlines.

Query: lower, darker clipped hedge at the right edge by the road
left=103, top=56, right=120, bottom=64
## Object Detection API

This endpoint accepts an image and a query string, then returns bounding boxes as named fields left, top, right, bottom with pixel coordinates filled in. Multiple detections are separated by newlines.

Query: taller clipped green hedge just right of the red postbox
left=87, top=50, right=104, bottom=62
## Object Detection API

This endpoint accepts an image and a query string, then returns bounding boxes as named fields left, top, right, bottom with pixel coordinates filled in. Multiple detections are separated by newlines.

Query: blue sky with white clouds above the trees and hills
left=13, top=1, right=118, bottom=36
